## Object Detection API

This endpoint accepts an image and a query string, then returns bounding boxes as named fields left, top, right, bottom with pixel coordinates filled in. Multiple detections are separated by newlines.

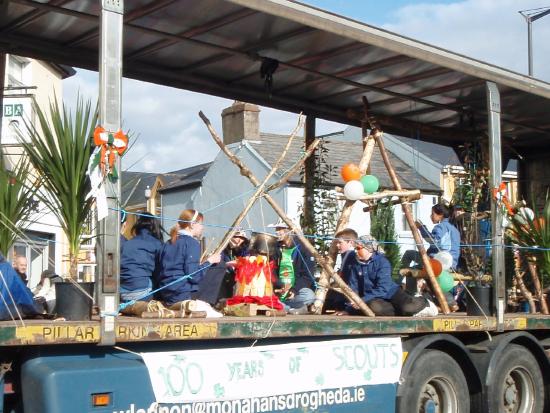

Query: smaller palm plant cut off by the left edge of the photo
left=0, top=153, right=37, bottom=257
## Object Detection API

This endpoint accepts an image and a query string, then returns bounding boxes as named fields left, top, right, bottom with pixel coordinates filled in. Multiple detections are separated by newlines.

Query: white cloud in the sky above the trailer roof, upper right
left=384, top=0, right=550, bottom=81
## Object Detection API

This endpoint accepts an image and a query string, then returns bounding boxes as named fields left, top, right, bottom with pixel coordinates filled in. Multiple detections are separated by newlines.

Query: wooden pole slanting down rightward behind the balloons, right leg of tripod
left=376, top=134, right=449, bottom=314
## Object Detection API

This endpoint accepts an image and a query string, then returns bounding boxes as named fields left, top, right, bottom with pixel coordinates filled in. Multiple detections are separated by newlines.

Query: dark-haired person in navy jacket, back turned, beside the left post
left=120, top=213, right=162, bottom=302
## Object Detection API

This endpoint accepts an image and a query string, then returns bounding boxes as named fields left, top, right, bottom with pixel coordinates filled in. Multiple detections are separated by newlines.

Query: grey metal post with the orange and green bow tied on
left=97, top=0, right=124, bottom=345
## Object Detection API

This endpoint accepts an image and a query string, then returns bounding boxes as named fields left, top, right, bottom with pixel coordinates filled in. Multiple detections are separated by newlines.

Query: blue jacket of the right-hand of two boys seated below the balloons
left=342, top=251, right=399, bottom=303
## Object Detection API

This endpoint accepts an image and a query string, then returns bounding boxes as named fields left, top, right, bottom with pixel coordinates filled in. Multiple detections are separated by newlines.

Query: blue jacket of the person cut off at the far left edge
left=0, top=254, right=38, bottom=320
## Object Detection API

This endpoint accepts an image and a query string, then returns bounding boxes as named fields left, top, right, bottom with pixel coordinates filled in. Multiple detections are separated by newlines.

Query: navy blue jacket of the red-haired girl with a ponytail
left=158, top=234, right=213, bottom=306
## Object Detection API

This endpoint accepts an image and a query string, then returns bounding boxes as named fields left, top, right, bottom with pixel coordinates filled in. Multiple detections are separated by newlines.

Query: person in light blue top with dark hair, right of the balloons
left=416, top=204, right=460, bottom=268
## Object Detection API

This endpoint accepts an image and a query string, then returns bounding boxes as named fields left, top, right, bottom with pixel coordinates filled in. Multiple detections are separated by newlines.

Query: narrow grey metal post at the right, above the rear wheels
left=486, top=82, right=506, bottom=331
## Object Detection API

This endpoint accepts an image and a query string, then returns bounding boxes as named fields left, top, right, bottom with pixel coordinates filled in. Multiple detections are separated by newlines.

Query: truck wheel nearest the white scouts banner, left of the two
left=396, top=350, right=470, bottom=413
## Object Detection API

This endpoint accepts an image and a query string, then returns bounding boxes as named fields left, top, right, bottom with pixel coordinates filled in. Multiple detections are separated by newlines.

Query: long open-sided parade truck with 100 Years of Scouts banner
left=0, top=0, right=550, bottom=413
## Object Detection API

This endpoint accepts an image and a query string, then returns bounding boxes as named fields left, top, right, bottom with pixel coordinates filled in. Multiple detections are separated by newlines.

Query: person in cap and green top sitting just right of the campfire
left=270, top=221, right=315, bottom=314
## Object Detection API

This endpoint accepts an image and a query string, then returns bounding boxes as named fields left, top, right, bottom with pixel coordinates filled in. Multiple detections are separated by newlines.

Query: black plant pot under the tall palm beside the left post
left=55, top=282, right=94, bottom=321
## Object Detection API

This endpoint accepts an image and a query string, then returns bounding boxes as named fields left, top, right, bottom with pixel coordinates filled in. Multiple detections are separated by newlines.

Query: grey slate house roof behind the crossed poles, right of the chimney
left=248, top=133, right=441, bottom=192
